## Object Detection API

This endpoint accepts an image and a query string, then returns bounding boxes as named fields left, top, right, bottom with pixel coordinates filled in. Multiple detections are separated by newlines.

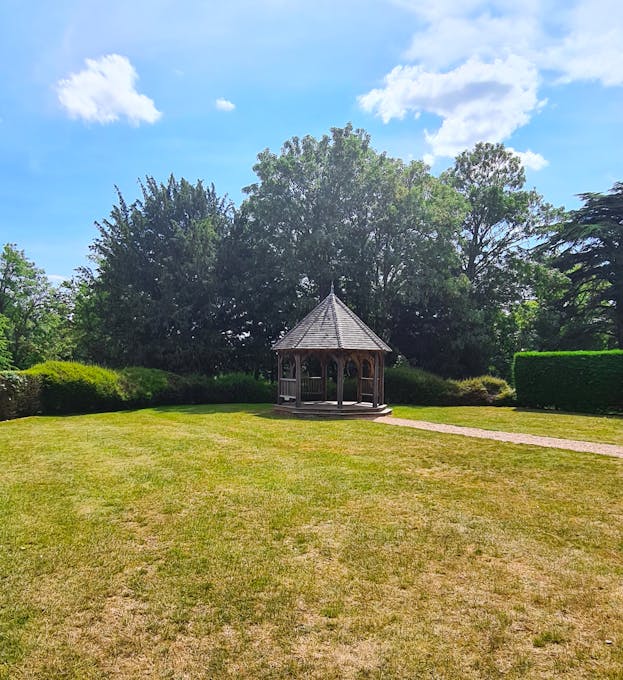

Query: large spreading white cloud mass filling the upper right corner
left=359, top=0, right=623, bottom=169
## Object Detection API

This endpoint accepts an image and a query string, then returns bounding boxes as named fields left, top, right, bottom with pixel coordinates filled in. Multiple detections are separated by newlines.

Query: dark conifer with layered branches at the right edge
left=547, top=182, right=623, bottom=348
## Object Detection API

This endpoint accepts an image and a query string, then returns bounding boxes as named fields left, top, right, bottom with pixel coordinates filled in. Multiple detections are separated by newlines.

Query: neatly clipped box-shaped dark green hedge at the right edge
left=513, top=350, right=623, bottom=413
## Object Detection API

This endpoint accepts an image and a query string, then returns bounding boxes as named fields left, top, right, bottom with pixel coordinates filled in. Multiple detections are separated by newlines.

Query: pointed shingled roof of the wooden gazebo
left=273, top=287, right=392, bottom=352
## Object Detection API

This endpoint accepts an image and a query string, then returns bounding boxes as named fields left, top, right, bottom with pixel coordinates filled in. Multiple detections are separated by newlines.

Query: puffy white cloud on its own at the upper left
left=57, top=54, right=162, bottom=125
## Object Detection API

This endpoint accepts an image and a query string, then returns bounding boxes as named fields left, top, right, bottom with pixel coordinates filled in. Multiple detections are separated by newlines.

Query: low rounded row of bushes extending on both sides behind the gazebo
left=0, top=361, right=513, bottom=420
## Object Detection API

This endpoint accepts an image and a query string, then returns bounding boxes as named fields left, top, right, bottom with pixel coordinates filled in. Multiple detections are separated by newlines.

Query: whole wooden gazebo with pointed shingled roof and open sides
left=273, top=286, right=391, bottom=418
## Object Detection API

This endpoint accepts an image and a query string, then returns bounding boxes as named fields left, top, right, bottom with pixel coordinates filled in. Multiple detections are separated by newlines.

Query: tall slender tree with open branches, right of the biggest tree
left=442, top=142, right=558, bottom=377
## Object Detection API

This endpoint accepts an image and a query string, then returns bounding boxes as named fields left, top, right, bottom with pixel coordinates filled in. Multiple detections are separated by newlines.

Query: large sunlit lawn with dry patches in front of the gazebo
left=0, top=406, right=623, bottom=680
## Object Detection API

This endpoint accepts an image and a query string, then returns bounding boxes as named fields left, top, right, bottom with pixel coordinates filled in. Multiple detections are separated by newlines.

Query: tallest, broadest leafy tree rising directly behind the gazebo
left=222, top=125, right=464, bottom=368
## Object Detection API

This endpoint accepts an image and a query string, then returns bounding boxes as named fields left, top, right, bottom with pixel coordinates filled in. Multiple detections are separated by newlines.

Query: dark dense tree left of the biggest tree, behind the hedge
left=76, top=176, right=232, bottom=372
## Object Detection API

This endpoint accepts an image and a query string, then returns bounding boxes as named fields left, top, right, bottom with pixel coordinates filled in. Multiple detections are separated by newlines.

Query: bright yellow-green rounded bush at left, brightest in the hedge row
left=22, top=361, right=125, bottom=413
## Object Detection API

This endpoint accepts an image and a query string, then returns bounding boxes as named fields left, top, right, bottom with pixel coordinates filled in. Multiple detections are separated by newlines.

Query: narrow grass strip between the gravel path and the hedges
left=392, top=406, right=623, bottom=445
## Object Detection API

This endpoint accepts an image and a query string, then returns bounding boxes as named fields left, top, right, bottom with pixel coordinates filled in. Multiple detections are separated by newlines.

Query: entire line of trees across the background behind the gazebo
left=0, top=125, right=623, bottom=378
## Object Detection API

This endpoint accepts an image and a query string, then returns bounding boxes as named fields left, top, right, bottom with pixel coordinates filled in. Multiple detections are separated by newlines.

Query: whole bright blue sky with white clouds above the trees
left=0, top=0, right=623, bottom=281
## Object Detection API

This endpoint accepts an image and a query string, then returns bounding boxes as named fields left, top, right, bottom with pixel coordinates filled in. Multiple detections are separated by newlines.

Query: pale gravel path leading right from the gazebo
left=374, top=416, right=623, bottom=458
